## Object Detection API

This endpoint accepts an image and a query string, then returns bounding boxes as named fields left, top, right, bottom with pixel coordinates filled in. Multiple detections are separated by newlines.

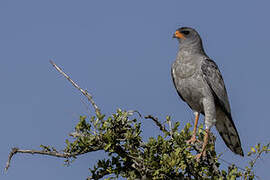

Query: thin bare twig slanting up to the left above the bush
left=50, top=60, right=101, bottom=116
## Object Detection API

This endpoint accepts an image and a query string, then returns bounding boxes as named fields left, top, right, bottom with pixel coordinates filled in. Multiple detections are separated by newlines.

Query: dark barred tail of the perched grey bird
left=216, top=108, right=244, bottom=156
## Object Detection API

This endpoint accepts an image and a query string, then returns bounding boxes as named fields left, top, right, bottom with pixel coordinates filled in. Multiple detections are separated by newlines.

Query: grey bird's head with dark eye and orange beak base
left=173, top=27, right=201, bottom=45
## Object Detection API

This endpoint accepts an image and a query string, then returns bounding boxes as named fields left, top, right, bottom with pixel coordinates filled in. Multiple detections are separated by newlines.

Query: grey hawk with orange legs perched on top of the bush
left=171, top=27, right=244, bottom=159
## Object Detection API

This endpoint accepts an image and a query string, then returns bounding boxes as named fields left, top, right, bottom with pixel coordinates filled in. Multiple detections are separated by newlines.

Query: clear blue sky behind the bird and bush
left=0, top=0, right=270, bottom=180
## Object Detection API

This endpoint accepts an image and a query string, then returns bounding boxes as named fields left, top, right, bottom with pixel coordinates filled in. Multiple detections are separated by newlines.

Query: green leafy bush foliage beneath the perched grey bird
left=38, top=109, right=270, bottom=180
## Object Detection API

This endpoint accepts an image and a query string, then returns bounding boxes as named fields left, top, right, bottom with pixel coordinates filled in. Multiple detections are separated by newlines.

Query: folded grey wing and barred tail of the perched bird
left=201, top=59, right=244, bottom=156
